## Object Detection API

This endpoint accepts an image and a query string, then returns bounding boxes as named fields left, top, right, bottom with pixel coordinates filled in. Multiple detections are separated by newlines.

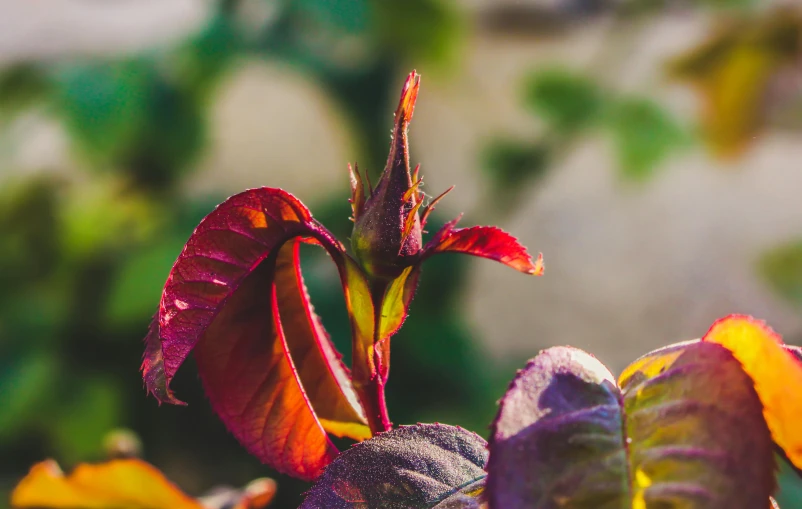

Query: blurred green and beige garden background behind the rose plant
left=0, top=0, right=802, bottom=508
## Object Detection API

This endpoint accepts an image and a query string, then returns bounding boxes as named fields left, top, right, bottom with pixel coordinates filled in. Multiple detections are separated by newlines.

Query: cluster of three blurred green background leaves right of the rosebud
left=482, top=68, right=691, bottom=208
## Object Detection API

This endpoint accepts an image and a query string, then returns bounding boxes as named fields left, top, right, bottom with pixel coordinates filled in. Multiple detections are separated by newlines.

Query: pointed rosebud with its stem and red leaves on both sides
left=142, top=71, right=543, bottom=468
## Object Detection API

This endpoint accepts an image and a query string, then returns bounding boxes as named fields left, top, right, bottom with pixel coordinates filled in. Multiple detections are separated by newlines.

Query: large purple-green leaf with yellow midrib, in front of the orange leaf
left=488, top=343, right=774, bottom=509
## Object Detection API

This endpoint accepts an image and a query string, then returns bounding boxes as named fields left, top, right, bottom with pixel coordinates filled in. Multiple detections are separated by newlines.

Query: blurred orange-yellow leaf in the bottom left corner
left=11, top=459, right=203, bottom=509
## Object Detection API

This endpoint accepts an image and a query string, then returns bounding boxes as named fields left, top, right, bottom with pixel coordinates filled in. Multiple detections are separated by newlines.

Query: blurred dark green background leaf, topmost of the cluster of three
left=525, top=70, right=604, bottom=134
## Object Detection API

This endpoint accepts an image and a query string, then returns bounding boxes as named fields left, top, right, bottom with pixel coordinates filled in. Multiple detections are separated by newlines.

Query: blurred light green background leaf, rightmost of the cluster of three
left=609, top=98, right=685, bottom=179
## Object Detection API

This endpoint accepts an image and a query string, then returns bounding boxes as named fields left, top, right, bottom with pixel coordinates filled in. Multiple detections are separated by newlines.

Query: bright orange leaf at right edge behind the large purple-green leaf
left=702, top=315, right=802, bottom=468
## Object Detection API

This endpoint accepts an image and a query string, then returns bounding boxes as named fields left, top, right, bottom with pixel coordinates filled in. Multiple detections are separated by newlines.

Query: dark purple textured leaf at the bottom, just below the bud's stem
left=300, top=424, right=487, bottom=509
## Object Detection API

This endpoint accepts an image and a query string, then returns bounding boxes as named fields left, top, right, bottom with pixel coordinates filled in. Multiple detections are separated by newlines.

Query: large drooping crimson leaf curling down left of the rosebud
left=143, top=188, right=370, bottom=480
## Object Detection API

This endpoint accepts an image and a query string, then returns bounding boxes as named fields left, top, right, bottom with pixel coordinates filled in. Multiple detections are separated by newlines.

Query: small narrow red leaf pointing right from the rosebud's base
left=423, top=217, right=543, bottom=276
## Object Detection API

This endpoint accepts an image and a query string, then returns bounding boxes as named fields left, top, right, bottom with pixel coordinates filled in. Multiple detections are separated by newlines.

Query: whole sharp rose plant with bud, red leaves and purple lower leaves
left=10, top=72, right=802, bottom=509
